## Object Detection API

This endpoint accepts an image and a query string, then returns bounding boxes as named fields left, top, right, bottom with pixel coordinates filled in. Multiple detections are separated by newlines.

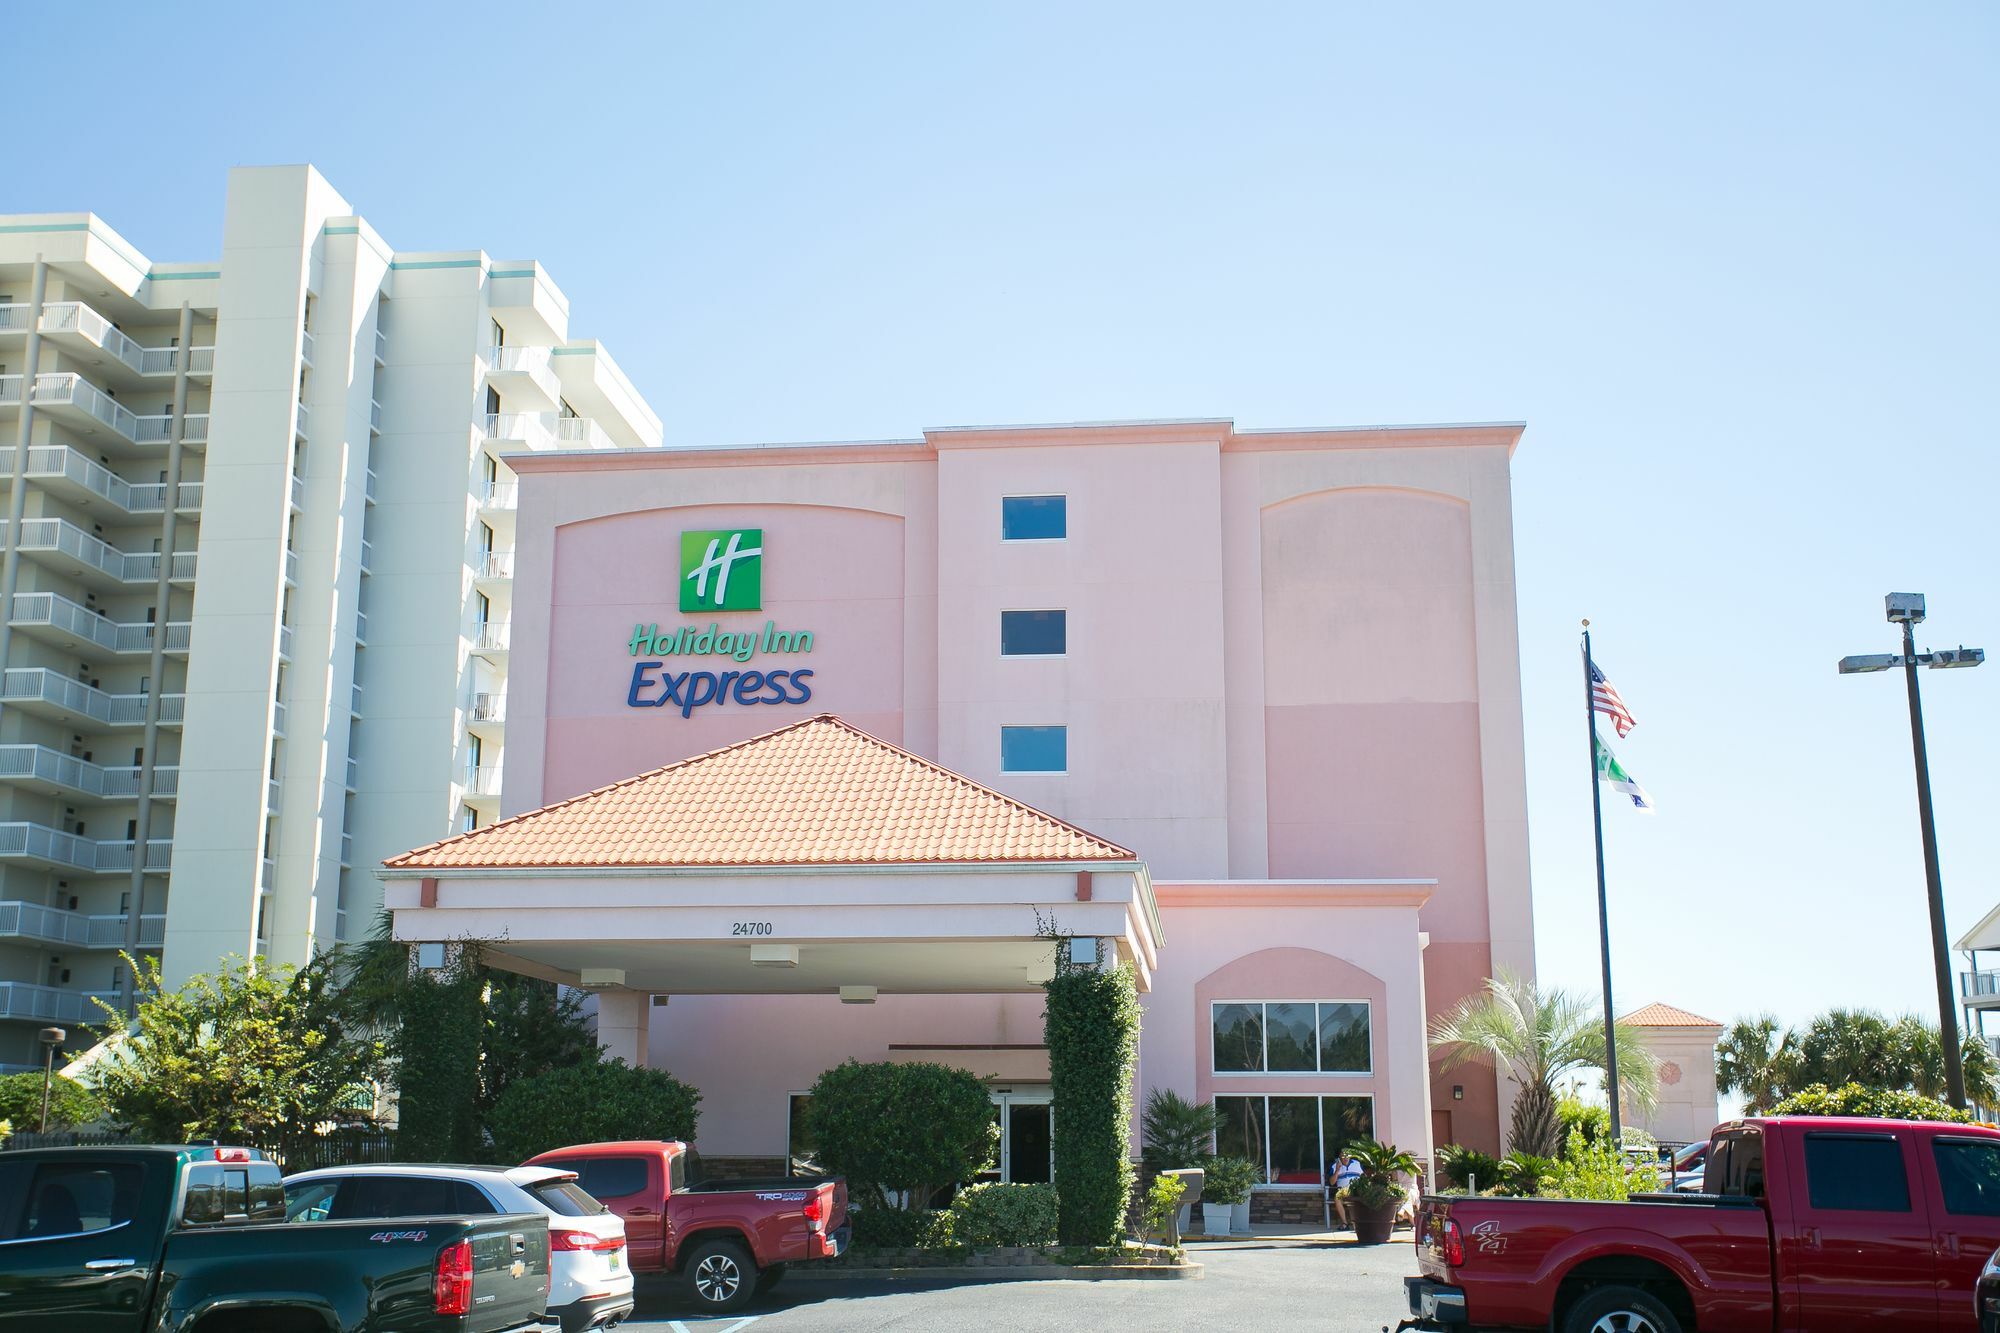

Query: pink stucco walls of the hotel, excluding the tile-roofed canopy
left=388, top=420, right=1534, bottom=1173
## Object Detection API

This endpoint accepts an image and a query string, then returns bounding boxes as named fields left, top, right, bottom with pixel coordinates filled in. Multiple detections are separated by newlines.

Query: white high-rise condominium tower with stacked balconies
left=0, top=166, right=660, bottom=1071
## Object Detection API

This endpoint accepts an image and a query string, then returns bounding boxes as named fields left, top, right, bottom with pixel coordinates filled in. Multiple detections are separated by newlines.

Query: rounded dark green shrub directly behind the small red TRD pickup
left=486, top=1061, right=702, bottom=1161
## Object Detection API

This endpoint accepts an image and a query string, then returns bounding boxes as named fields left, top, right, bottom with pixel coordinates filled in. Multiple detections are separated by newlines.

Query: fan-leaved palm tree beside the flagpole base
left=1430, top=971, right=1660, bottom=1157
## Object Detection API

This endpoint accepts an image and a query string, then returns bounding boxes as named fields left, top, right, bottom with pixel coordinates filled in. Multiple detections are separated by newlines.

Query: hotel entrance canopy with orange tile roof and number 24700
left=382, top=715, right=1160, bottom=999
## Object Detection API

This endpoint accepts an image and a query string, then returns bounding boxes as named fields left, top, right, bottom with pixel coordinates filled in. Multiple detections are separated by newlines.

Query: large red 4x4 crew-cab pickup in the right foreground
left=1402, top=1117, right=2000, bottom=1333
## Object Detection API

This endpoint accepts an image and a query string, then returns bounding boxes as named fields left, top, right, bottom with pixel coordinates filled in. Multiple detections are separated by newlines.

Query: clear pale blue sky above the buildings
left=19, top=2, right=2000, bottom=1019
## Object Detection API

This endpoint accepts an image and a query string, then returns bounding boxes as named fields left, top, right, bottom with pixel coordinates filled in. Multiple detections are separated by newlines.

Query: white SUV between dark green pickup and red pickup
left=284, top=1163, right=632, bottom=1333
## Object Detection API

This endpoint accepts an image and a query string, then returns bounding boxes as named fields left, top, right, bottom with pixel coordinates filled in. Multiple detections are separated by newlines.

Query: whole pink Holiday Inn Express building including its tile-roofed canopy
left=384, top=420, right=1534, bottom=1189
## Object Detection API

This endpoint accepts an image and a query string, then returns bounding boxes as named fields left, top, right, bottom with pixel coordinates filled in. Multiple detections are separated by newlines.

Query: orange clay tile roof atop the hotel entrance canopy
left=382, top=713, right=1138, bottom=871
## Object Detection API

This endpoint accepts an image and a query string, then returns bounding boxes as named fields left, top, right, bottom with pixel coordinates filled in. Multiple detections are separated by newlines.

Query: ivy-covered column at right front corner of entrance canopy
left=1042, top=956, right=1140, bottom=1245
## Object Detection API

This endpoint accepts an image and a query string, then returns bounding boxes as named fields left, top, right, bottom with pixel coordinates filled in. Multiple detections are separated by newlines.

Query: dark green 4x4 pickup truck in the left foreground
left=0, top=1147, right=554, bottom=1333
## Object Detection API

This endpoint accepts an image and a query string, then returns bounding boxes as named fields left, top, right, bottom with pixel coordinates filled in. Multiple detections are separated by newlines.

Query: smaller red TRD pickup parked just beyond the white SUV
left=524, top=1139, right=848, bottom=1313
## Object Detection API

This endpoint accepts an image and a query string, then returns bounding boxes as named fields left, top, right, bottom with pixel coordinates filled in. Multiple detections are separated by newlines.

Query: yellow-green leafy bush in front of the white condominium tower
left=92, top=955, right=382, bottom=1149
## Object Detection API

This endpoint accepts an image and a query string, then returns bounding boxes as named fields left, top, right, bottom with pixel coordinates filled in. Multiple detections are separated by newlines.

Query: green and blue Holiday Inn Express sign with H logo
left=626, top=528, right=812, bottom=717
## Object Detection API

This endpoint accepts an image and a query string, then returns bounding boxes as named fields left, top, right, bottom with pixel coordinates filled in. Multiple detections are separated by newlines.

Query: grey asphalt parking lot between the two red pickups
left=622, top=1237, right=1414, bottom=1333
